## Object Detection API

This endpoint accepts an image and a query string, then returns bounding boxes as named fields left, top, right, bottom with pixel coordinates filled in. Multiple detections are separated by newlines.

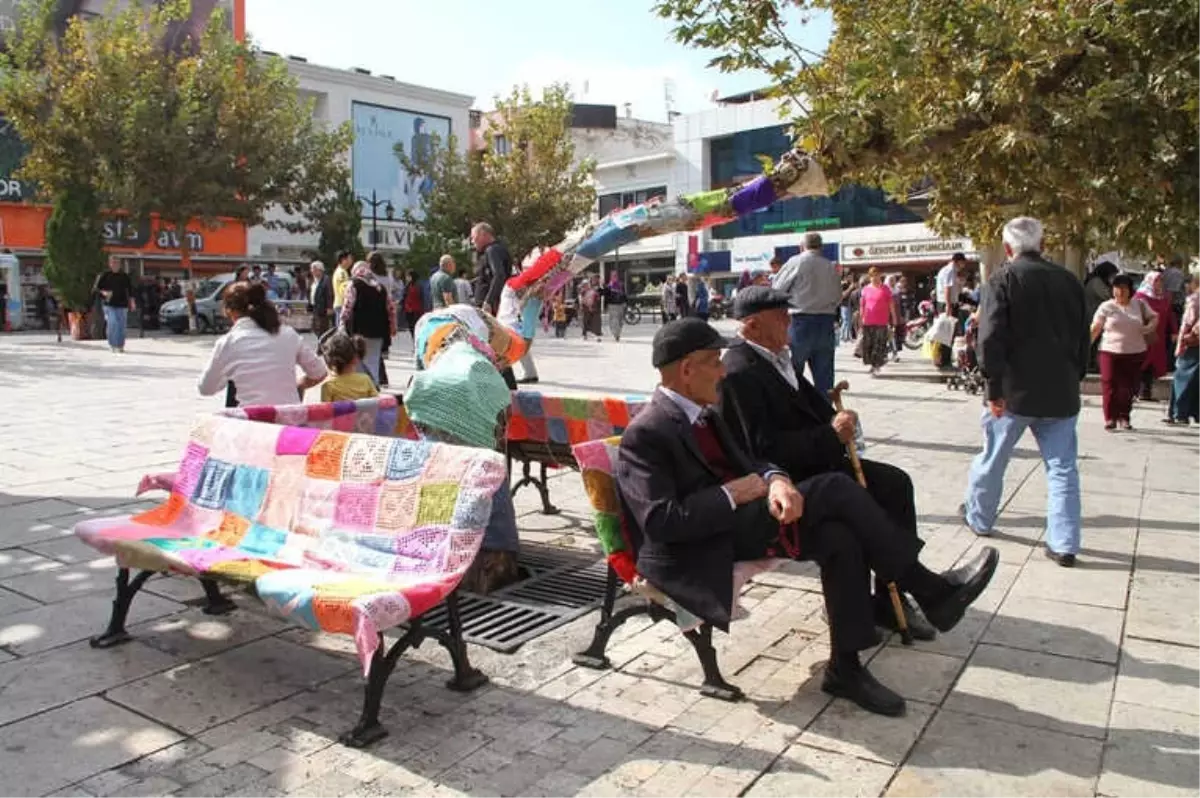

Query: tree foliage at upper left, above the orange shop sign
left=0, top=0, right=352, bottom=255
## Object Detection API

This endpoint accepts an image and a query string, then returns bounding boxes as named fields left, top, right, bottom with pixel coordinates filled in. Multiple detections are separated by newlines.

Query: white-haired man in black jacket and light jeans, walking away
left=960, top=216, right=1091, bottom=568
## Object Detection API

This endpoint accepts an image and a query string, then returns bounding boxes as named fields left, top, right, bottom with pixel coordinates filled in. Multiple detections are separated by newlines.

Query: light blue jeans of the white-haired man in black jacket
left=965, top=408, right=1082, bottom=554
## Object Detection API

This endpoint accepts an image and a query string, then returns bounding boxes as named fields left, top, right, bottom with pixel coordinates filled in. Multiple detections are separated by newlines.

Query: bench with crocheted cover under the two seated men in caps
left=572, top=437, right=787, bottom=701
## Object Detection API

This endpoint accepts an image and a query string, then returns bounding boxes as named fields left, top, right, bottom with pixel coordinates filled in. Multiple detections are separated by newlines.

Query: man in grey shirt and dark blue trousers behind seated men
left=772, top=233, right=841, bottom=396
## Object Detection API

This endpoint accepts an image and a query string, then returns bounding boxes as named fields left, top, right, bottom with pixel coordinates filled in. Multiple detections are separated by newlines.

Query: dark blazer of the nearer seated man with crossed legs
left=617, top=391, right=779, bottom=631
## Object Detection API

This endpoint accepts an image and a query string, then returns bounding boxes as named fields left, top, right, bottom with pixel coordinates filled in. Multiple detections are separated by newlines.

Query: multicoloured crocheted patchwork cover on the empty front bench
left=74, top=412, right=505, bottom=671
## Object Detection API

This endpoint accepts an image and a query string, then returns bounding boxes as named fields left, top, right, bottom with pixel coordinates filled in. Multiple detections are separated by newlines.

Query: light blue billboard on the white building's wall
left=350, top=102, right=450, bottom=220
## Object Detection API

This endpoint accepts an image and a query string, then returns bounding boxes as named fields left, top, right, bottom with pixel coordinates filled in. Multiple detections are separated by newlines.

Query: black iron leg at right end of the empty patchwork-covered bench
left=337, top=593, right=487, bottom=748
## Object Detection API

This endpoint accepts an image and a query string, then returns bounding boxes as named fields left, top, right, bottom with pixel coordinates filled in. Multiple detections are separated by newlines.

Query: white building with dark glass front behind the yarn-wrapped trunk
left=670, top=94, right=977, bottom=292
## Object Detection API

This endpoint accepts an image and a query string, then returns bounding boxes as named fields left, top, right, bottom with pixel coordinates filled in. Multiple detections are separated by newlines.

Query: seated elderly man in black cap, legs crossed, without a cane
left=617, top=318, right=998, bottom=715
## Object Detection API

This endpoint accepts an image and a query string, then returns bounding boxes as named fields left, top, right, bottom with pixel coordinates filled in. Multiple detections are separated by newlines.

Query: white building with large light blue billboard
left=247, top=54, right=474, bottom=263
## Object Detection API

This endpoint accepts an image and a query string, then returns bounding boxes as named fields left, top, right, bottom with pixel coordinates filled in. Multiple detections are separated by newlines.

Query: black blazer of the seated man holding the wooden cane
left=718, top=341, right=846, bottom=482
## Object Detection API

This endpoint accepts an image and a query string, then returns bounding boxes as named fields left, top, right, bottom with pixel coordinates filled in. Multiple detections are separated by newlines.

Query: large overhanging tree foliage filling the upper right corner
left=655, top=0, right=1200, bottom=251
